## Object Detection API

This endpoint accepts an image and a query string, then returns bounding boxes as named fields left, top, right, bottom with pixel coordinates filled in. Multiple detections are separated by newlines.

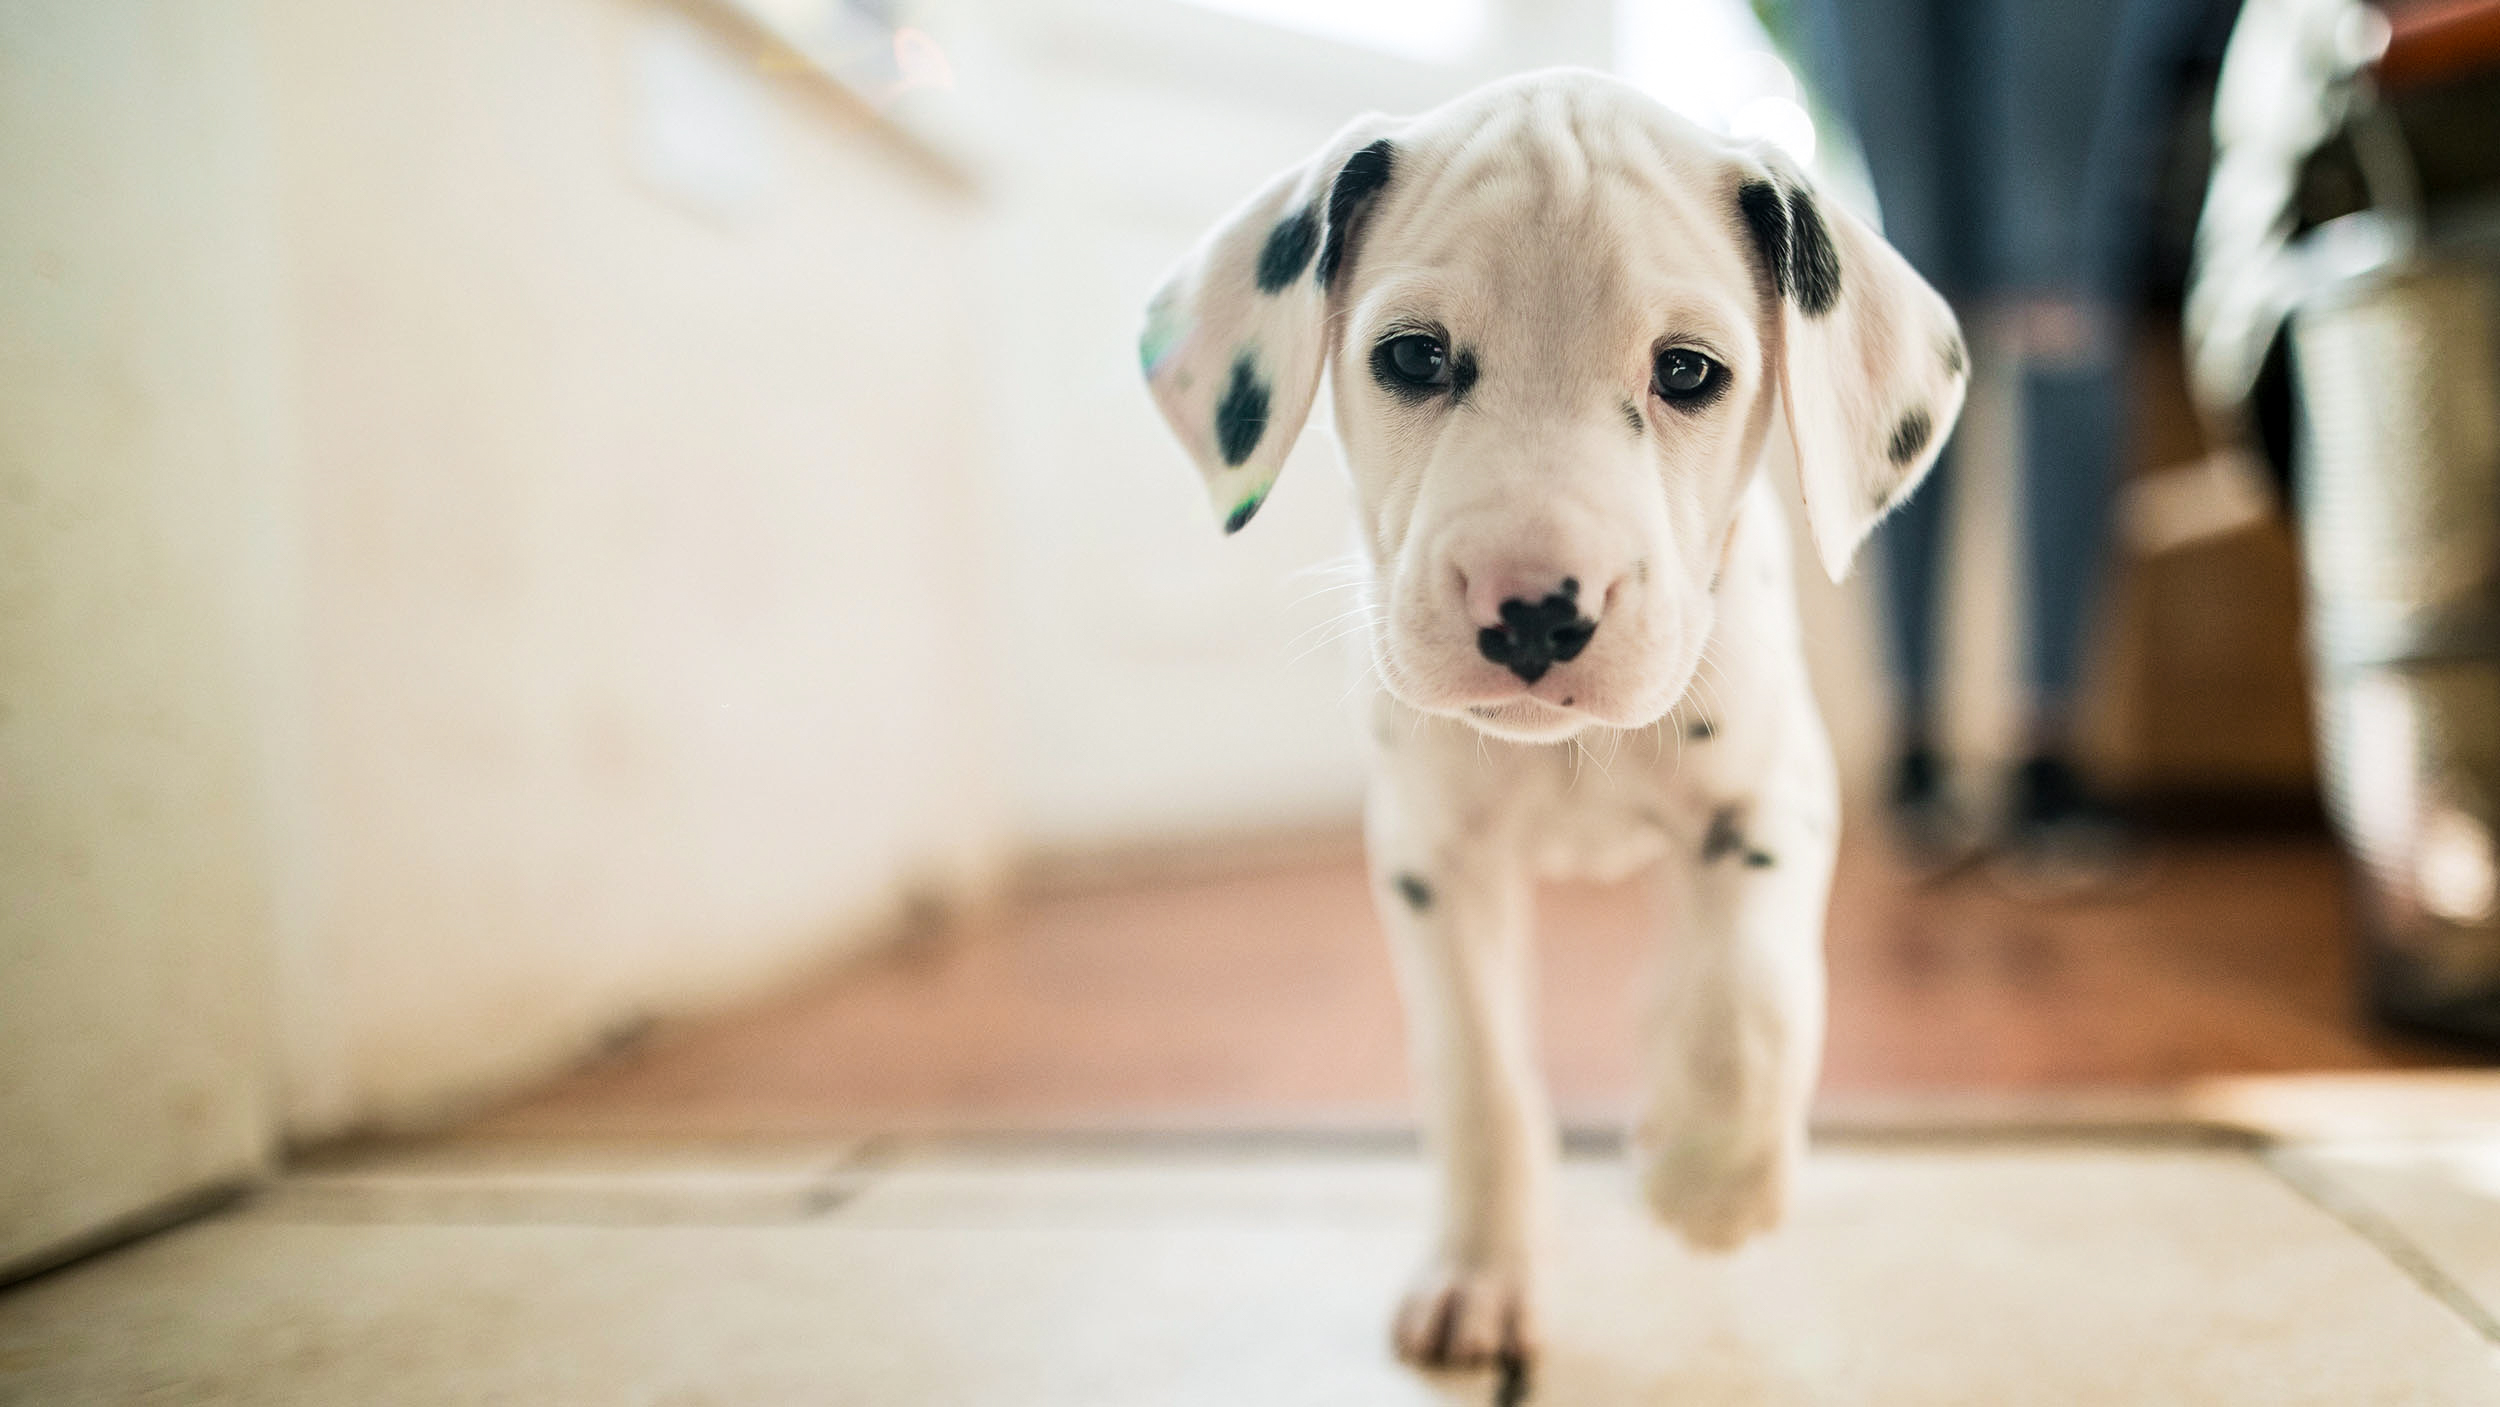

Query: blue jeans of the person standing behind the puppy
left=1790, top=0, right=2205, bottom=740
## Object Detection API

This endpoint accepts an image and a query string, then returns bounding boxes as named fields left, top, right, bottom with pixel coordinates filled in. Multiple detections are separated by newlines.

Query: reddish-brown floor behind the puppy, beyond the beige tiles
left=490, top=835, right=2440, bottom=1137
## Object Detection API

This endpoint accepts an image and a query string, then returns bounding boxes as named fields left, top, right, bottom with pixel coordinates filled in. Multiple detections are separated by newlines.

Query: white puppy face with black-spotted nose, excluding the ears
left=1330, top=102, right=1778, bottom=740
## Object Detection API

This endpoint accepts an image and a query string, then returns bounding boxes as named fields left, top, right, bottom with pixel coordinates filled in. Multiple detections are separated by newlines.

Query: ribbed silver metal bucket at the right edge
left=2290, top=250, right=2500, bottom=1042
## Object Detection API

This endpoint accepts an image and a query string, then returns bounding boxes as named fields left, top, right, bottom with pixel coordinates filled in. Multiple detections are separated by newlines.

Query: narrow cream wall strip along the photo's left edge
left=0, top=0, right=278, bottom=1277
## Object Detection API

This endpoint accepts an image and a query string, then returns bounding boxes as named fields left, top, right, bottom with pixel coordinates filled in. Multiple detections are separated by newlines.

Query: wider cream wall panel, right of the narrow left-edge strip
left=263, top=0, right=1000, bottom=1130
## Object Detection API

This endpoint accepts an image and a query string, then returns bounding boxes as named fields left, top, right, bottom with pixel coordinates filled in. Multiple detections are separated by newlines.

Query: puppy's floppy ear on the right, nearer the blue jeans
left=1735, top=165, right=1970, bottom=582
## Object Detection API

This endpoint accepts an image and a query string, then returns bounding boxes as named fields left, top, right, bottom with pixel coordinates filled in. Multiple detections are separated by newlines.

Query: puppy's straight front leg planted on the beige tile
left=1370, top=787, right=1558, bottom=1367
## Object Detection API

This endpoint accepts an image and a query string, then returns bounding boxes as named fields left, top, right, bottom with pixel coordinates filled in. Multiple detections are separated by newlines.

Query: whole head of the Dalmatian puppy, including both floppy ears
left=1140, top=72, right=1965, bottom=742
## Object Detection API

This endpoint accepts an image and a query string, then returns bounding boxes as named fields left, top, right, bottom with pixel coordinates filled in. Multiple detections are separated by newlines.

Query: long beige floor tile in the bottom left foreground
left=0, top=1222, right=1440, bottom=1407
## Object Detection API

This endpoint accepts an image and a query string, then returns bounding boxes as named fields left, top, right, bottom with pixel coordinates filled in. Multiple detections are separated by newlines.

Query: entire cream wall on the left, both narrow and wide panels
left=0, top=0, right=1005, bottom=1189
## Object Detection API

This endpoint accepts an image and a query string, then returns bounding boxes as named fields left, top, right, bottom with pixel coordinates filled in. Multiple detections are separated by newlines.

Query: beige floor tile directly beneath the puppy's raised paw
left=1548, top=1150, right=2500, bottom=1405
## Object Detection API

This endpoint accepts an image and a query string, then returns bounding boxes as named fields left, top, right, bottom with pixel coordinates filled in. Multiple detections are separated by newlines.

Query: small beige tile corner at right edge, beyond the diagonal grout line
left=2275, top=1132, right=2500, bottom=1332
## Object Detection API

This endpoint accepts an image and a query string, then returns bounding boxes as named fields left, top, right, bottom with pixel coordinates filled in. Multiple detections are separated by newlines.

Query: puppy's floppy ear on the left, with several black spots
left=1138, top=117, right=1398, bottom=532
